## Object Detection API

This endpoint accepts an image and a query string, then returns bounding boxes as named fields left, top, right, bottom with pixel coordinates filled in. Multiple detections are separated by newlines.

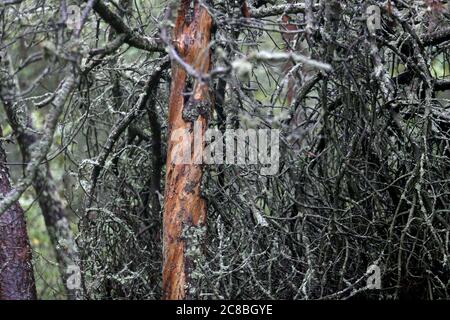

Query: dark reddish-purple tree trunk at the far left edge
left=0, top=128, right=36, bottom=300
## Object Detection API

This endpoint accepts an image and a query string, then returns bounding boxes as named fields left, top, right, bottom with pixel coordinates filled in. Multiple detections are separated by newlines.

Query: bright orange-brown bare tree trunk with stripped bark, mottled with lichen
left=163, top=0, right=212, bottom=299
